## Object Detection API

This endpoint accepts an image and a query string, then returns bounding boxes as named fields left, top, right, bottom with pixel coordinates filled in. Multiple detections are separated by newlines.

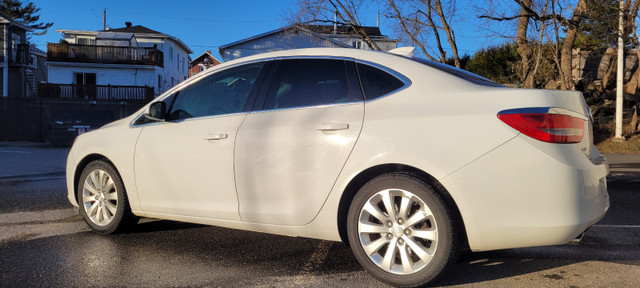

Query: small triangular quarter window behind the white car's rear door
left=357, top=63, right=404, bottom=100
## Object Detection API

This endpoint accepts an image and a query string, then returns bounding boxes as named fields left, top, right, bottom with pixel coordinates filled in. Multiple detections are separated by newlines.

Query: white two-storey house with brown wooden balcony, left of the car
left=45, top=22, right=193, bottom=99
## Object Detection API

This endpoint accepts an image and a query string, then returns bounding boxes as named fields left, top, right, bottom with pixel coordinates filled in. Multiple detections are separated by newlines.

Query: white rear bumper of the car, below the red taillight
left=442, top=135, right=609, bottom=251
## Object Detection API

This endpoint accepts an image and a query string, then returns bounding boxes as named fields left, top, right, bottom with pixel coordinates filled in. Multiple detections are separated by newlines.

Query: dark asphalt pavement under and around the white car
left=0, top=145, right=640, bottom=287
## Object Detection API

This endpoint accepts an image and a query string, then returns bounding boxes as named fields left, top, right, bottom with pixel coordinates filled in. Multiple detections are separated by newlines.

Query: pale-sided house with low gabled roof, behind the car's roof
left=219, top=24, right=398, bottom=61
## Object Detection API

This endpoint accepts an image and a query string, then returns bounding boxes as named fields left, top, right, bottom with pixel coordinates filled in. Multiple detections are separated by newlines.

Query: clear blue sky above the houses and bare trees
left=30, top=0, right=504, bottom=59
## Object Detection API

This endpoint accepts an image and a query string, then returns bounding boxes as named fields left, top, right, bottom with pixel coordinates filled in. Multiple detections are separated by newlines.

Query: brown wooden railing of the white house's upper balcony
left=47, top=43, right=164, bottom=67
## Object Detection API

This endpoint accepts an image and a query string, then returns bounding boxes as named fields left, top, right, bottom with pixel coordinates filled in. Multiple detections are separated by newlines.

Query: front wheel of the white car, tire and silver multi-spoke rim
left=76, top=160, right=139, bottom=234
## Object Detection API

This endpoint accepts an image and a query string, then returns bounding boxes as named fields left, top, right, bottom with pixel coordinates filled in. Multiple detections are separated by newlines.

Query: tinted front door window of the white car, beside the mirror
left=167, top=62, right=264, bottom=120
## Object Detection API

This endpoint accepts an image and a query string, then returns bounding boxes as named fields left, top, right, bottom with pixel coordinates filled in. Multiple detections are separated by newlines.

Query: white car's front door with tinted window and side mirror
left=135, top=63, right=265, bottom=220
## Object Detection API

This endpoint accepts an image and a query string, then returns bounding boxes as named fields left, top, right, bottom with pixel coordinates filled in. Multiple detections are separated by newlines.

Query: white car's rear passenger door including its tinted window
left=235, top=59, right=364, bottom=225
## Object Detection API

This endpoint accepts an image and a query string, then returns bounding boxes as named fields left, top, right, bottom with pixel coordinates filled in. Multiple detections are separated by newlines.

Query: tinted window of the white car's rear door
left=264, top=59, right=363, bottom=109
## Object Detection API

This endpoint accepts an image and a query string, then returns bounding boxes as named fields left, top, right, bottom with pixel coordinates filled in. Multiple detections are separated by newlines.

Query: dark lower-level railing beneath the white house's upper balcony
left=38, top=83, right=154, bottom=102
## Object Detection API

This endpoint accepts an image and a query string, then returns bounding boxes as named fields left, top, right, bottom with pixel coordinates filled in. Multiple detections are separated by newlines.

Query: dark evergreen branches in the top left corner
left=0, top=0, right=53, bottom=35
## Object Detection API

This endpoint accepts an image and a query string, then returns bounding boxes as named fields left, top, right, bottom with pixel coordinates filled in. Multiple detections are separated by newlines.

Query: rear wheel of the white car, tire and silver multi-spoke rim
left=347, top=173, right=460, bottom=287
